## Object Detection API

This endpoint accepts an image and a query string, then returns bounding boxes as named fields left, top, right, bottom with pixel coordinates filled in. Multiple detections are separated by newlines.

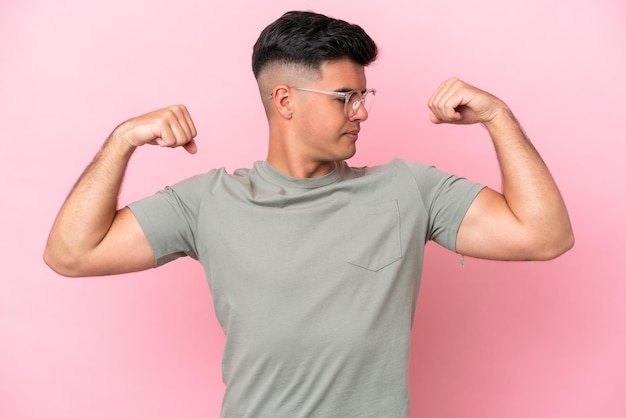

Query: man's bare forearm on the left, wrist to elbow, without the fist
left=44, top=131, right=135, bottom=272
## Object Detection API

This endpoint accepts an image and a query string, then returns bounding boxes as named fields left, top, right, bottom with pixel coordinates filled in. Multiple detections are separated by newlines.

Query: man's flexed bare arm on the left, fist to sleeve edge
left=44, top=105, right=197, bottom=277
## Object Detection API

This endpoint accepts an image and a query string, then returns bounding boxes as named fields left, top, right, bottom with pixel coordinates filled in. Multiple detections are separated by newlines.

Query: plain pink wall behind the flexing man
left=0, top=0, right=626, bottom=418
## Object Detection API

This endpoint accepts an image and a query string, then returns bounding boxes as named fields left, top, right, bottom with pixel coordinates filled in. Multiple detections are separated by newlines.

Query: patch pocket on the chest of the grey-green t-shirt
left=346, top=200, right=402, bottom=271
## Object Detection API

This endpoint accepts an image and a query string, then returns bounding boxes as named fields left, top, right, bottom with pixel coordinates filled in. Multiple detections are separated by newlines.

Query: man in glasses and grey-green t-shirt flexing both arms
left=45, top=12, right=573, bottom=417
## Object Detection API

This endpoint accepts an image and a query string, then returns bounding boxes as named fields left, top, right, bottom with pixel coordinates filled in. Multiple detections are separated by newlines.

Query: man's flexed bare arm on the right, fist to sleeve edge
left=429, top=78, right=574, bottom=260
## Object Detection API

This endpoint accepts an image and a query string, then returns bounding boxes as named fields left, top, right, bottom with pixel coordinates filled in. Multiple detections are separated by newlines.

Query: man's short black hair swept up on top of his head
left=252, top=11, right=378, bottom=79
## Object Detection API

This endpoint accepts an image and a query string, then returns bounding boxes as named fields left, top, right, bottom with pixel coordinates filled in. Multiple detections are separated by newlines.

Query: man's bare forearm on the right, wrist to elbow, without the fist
left=484, top=107, right=573, bottom=258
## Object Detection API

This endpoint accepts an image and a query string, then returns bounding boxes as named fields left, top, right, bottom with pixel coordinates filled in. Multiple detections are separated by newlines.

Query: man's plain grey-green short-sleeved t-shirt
left=129, top=160, right=482, bottom=418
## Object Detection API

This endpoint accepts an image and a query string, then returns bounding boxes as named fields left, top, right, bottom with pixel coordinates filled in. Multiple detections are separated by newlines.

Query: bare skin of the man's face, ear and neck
left=262, top=60, right=368, bottom=178
